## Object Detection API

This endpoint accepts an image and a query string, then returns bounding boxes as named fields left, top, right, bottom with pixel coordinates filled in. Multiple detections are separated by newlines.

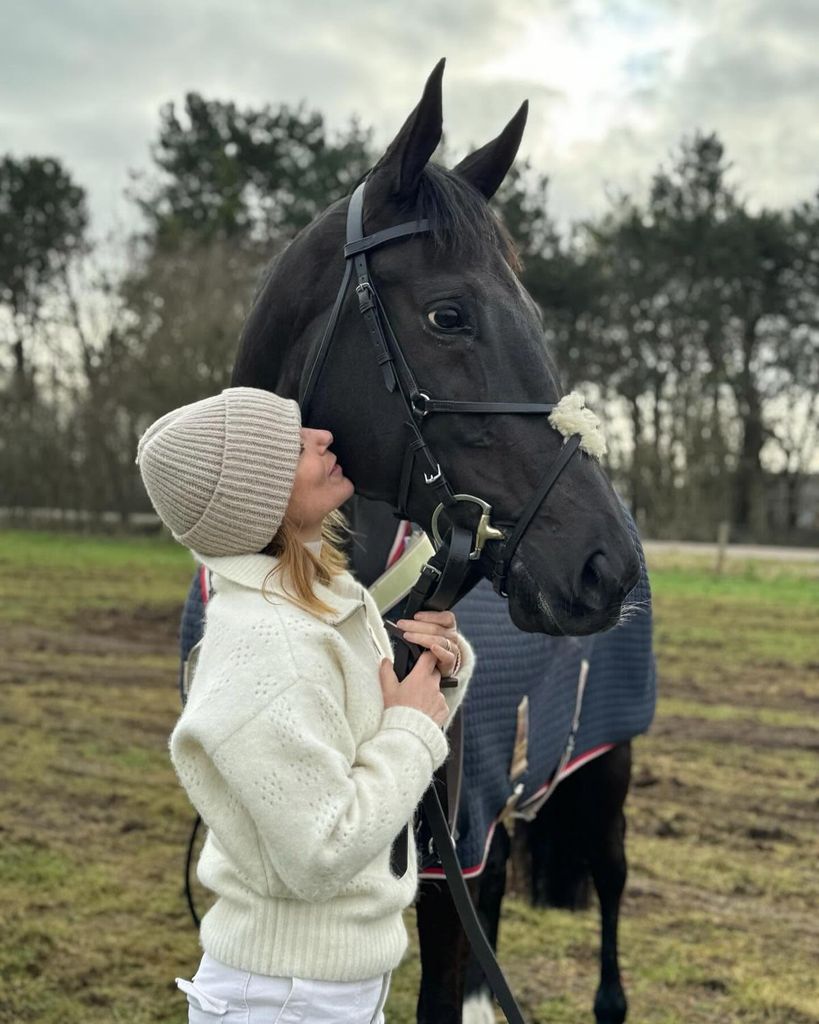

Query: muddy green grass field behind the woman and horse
left=0, top=531, right=819, bottom=1024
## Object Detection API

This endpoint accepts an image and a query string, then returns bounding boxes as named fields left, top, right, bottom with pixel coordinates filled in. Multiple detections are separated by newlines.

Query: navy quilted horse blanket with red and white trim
left=180, top=517, right=656, bottom=878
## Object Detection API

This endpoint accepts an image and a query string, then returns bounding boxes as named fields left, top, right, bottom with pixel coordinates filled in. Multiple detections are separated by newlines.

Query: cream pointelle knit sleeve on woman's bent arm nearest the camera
left=176, top=679, right=447, bottom=902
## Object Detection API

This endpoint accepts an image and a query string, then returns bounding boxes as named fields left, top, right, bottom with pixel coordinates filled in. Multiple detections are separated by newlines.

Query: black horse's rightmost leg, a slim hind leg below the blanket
left=583, top=742, right=632, bottom=1024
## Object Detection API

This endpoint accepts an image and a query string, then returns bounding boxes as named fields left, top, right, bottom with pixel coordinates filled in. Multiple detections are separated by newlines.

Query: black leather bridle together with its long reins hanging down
left=299, top=180, right=583, bottom=1024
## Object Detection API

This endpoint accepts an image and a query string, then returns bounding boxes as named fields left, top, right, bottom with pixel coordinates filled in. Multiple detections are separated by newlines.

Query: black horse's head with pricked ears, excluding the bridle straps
left=233, top=61, right=639, bottom=634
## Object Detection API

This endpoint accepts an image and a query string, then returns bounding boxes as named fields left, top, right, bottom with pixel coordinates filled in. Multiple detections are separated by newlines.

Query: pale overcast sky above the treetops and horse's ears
left=0, top=0, right=819, bottom=232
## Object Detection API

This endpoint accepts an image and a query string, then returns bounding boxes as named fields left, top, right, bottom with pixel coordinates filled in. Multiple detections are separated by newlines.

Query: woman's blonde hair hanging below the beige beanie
left=261, top=509, right=349, bottom=614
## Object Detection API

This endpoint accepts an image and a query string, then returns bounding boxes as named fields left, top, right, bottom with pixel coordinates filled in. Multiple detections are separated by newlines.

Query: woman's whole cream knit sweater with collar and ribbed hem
left=170, top=555, right=474, bottom=981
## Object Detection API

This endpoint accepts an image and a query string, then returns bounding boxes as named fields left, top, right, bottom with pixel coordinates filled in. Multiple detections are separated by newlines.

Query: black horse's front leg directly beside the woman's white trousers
left=416, top=879, right=477, bottom=1024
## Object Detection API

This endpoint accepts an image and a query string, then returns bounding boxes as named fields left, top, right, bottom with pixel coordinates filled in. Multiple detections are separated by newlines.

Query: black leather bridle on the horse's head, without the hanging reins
left=299, top=180, right=580, bottom=608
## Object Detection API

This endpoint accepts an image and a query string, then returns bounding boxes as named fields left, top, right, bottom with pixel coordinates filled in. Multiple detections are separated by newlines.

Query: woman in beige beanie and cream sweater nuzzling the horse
left=137, top=388, right=473, bottom=1024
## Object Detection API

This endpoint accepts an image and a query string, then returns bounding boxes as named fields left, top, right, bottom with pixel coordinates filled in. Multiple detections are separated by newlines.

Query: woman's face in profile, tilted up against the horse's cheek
left=288, top=427, right=354, bottom=541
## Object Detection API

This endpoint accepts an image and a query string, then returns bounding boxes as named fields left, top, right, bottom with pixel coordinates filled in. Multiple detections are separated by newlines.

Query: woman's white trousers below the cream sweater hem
left=176, top=953, right=390, bottom=1024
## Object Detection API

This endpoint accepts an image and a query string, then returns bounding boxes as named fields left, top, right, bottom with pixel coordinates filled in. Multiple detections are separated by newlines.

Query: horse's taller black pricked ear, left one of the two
left=368, top=57, right=446, bottom=202
